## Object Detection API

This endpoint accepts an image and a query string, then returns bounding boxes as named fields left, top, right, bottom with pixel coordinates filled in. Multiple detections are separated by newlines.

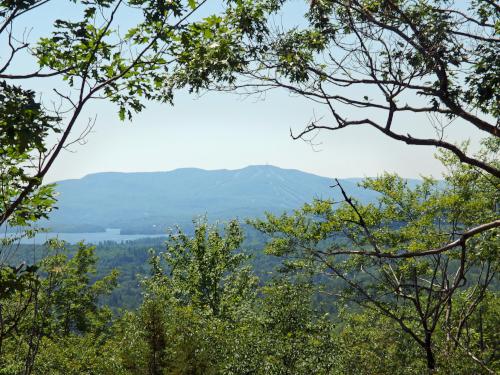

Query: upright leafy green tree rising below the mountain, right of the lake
left=157, top=220, right=256, bottom=317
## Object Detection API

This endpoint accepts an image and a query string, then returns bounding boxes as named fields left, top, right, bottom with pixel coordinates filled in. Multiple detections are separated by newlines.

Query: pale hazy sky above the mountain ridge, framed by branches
left=6, top=1, right=484, bottom=182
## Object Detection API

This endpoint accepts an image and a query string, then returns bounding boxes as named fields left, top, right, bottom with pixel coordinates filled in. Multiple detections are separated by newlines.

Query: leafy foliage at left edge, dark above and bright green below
left=0, top=81, right=58, bottom=239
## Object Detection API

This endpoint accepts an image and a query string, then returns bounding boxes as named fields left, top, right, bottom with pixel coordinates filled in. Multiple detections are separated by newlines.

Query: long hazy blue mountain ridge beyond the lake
left=49, top=165, right=382, bottom=234
